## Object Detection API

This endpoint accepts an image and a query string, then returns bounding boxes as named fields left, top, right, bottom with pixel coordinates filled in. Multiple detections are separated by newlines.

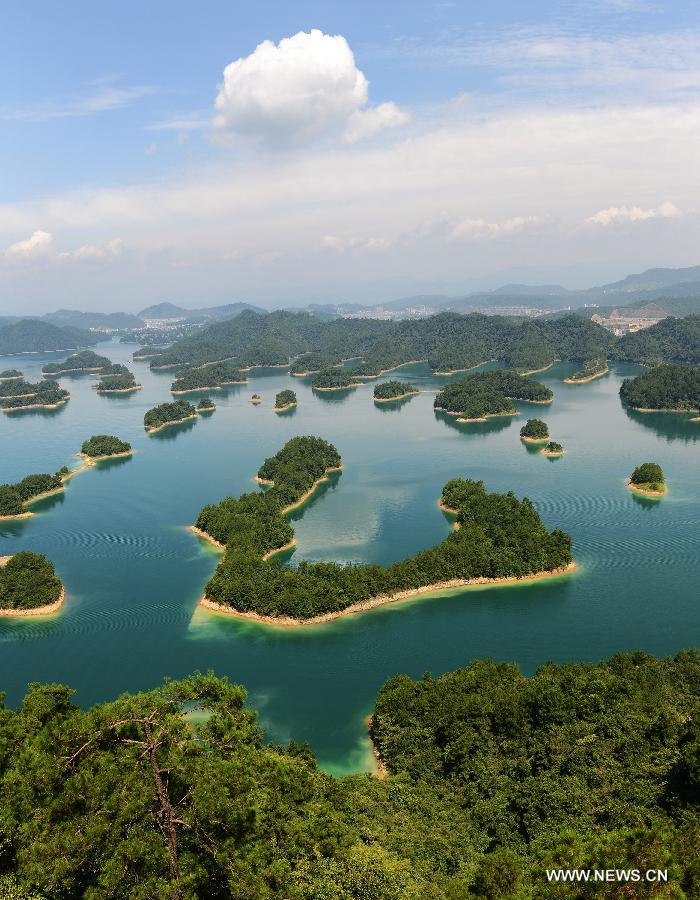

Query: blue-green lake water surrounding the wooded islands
left=0, top=343, right=700, bottom=772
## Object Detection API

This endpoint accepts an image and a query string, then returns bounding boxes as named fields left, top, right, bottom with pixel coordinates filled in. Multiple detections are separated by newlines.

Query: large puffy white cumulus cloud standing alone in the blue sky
left=214, top=29, right=409, bottom=146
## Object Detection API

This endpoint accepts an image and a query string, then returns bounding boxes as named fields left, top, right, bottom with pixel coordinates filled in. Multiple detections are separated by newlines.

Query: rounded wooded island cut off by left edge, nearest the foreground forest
left=0, top=551, right=66, bottom=616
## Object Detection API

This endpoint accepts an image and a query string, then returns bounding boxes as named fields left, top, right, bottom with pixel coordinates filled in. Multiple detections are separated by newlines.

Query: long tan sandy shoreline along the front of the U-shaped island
left=199, top=562, right=576, bottom=628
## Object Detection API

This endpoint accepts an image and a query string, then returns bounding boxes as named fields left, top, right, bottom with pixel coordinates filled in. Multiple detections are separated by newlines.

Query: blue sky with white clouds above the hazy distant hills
left=0, top=0, right=700, bottom=315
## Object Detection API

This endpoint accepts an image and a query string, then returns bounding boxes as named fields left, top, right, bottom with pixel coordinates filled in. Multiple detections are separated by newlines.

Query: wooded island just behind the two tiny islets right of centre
left=433, top=370, right=554, bottom=422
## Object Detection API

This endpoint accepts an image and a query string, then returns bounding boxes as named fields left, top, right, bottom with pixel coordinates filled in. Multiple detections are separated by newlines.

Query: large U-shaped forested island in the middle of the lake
left=189, top=436, right=574, bottom=626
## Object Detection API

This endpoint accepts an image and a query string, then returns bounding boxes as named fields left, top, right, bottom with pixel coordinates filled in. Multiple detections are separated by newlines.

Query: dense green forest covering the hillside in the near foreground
left=0, top=651, right=700, bottom=900
